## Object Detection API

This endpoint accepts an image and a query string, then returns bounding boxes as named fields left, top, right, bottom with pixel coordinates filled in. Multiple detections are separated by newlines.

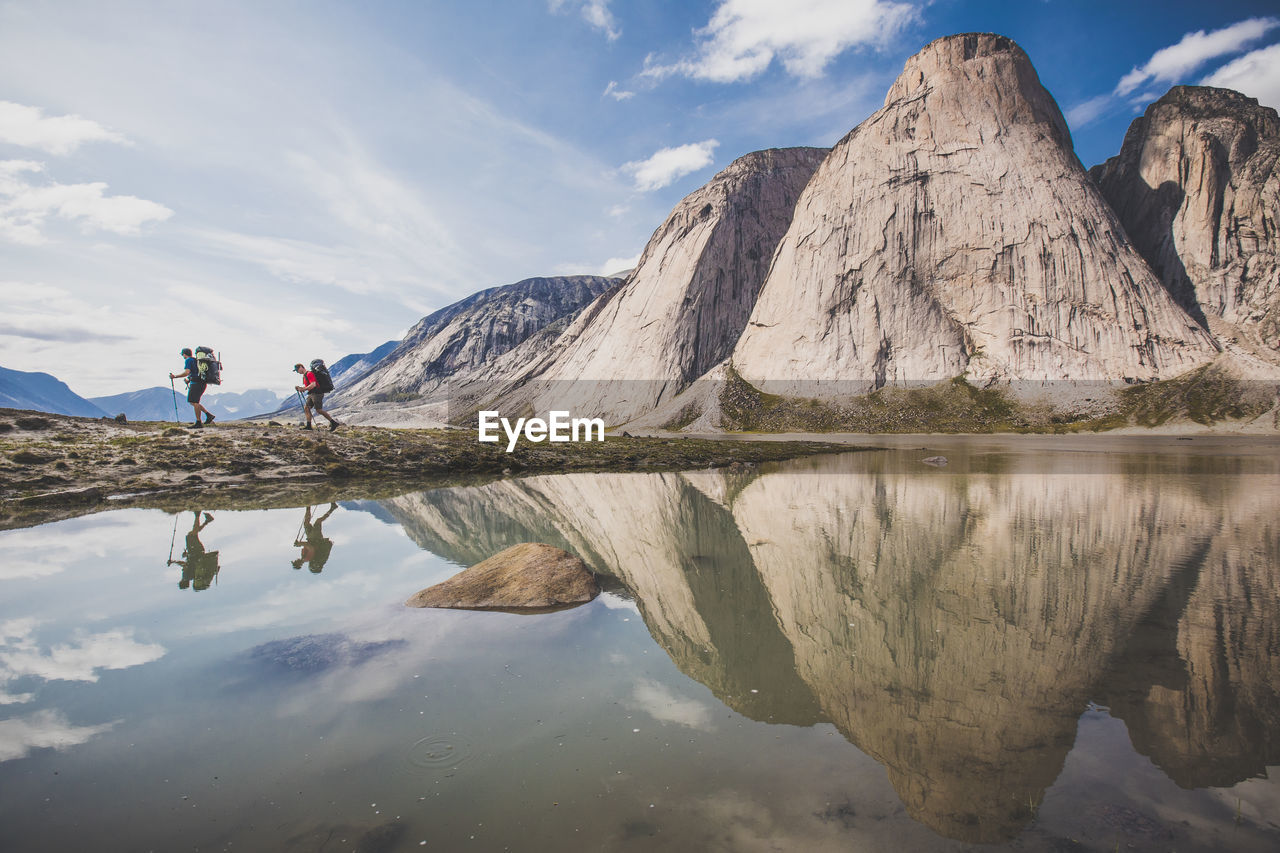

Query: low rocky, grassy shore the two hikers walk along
left=0, top=409, right=850, bottom=529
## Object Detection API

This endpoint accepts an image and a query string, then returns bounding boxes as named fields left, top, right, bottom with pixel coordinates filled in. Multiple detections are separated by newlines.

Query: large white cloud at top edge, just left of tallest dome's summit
left=641, top=0, right=916, bottom=83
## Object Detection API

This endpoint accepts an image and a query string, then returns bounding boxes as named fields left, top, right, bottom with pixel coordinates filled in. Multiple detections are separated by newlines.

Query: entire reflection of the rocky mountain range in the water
left=387, top=453, right=1280, bottom=841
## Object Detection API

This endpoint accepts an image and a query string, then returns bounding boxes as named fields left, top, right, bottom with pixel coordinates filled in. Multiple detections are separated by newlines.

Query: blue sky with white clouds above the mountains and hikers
left=0, top=0, right=1280, bottom=396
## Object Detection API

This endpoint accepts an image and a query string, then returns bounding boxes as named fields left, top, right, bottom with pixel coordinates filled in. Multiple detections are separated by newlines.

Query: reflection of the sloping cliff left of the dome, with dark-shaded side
left=385, top=474, right=820, bottom=725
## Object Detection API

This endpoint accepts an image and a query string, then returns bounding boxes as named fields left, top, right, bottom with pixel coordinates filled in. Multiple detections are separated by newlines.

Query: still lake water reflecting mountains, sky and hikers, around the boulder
left=0, top=439, right=1280, bottom=852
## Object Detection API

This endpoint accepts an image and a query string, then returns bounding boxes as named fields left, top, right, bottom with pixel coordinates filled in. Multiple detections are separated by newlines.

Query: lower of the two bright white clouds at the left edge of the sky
left=0, top=160, right=173, bottom=246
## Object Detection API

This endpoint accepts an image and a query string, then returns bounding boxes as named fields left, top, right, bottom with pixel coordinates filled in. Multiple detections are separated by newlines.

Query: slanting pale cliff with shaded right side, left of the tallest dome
left=483, top=149, right=827, bottom=423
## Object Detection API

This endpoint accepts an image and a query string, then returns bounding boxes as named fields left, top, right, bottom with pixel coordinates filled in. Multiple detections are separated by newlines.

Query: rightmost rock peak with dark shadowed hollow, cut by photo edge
left=1091, top=86, right=1280, bottom=362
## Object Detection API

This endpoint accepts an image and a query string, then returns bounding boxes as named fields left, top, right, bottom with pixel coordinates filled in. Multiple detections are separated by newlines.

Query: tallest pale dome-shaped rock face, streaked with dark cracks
left=732, top=33, right=1216, bottom=396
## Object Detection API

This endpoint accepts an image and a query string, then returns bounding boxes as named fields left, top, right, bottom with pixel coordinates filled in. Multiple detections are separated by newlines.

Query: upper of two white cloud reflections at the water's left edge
left=0, top=619, right=165, bottom=701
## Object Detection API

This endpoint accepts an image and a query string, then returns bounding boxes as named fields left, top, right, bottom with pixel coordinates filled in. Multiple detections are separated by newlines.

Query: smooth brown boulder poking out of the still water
left=404, top=542, right=600, bottom=610
